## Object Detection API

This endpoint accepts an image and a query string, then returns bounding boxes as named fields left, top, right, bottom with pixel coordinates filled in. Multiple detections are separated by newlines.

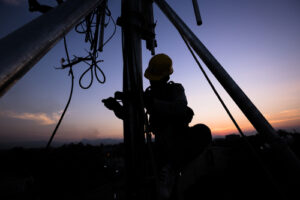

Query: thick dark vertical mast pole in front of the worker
left=121, top=0, right=145, bottom=200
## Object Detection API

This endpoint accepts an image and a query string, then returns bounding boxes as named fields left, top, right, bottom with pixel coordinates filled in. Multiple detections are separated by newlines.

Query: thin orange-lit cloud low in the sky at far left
left=2, top=111, right=61, bottom=125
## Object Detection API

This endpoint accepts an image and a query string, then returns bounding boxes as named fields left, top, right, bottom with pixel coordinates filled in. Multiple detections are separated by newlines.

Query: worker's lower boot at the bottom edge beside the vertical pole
left=158, top=165, right=176, bottom=200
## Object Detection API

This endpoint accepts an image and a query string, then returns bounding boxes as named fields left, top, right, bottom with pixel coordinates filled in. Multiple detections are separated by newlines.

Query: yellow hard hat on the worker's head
left=144, top=54, right=173, bottom=81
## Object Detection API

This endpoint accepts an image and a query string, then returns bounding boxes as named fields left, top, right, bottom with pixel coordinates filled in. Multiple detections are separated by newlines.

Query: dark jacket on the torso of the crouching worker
left=145, top=81, right=194, bottom=135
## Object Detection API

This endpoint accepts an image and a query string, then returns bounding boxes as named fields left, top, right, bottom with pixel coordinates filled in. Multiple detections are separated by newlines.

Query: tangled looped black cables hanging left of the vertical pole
left=46, top=0, right=116, bottom=149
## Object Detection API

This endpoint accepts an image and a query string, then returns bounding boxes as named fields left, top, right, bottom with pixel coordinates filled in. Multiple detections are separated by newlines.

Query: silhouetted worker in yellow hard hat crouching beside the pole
left=103, top=54, right=212, bottom=199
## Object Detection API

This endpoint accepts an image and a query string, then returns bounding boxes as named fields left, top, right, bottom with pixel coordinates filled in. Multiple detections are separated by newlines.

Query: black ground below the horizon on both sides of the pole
left=0, top=131, right=300, bottom=200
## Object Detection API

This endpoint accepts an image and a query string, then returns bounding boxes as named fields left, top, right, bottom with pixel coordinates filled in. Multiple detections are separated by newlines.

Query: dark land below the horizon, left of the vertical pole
left=0, top=143, right=124, bottom=199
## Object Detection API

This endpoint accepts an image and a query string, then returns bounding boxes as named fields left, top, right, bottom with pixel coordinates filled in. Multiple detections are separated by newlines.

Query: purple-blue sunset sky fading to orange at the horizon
left=0, top=0, right=300, bottom=145
